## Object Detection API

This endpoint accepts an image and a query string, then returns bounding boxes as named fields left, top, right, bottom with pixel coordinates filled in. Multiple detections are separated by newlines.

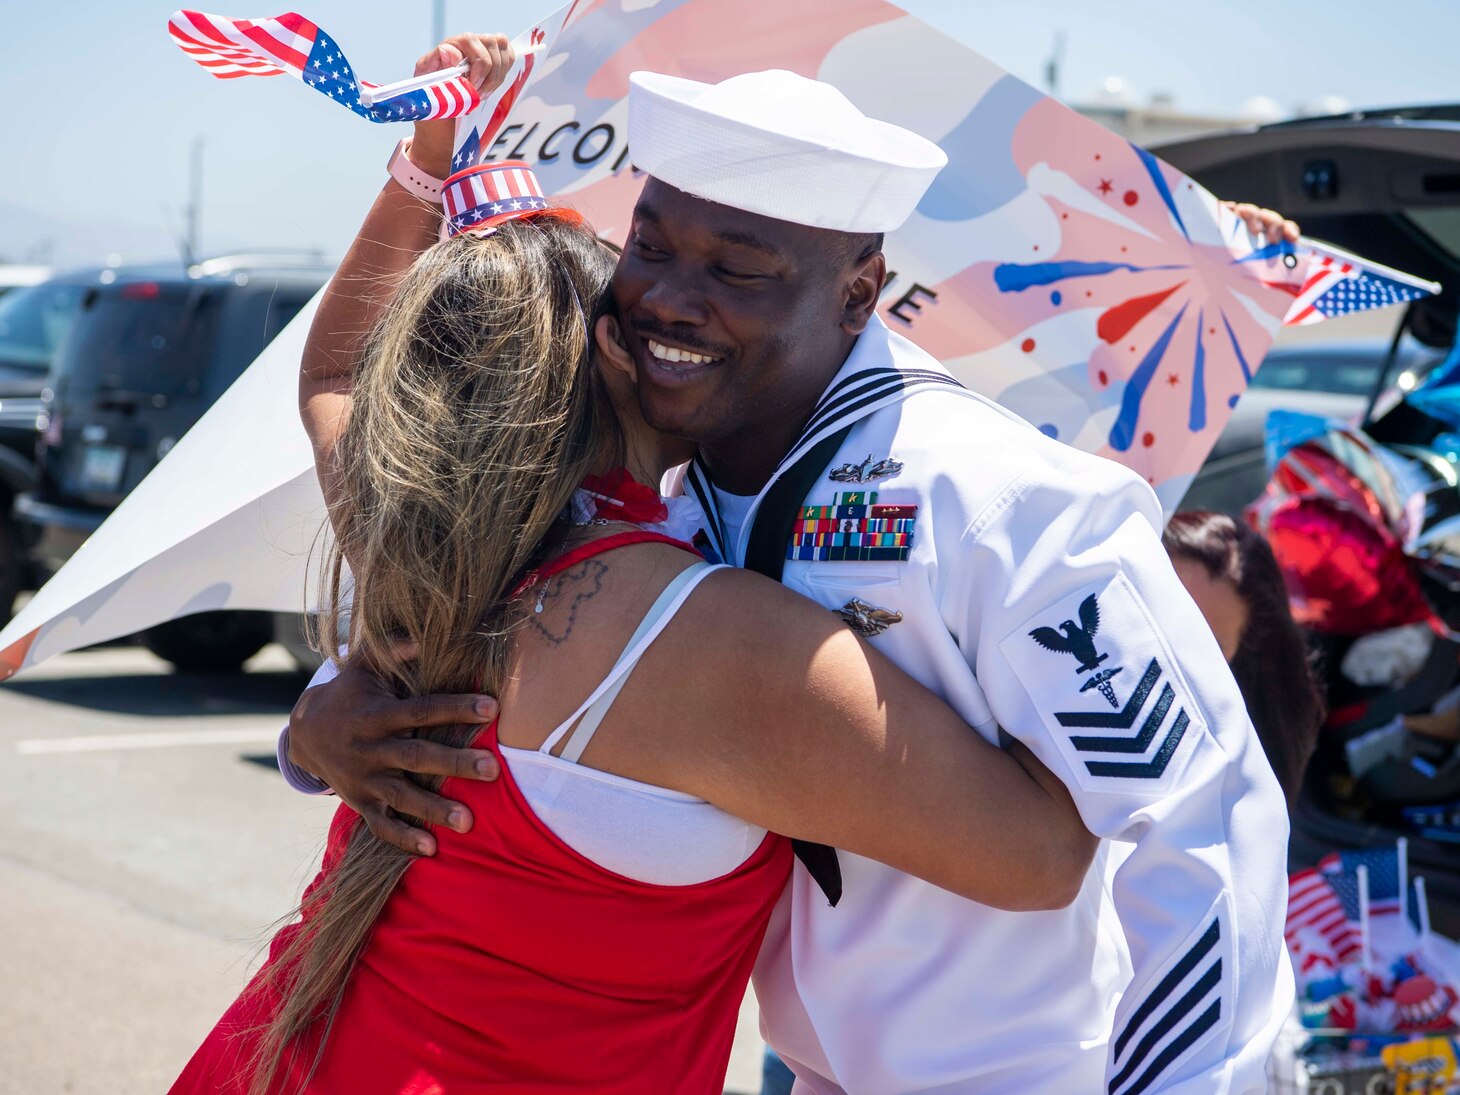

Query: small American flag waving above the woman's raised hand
left=168, top=10, right=480, bottom=121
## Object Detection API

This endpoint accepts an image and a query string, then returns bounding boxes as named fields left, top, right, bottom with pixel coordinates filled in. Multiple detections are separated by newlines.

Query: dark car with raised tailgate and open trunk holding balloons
left=1155, top=105, right=1460, bottom=916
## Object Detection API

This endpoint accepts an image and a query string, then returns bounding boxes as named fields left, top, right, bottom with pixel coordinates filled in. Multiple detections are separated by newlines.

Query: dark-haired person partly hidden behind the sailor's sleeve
left=1161, top=510, right=1324, bottom=807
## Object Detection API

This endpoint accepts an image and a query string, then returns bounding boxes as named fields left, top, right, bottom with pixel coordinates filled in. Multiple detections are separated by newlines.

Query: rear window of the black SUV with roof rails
left=57, top=282, right=216, bottom=397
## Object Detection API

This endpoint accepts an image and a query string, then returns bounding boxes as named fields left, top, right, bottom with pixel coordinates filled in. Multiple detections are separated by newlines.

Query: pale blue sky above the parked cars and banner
left=0, top=0, right=1460, bottom=266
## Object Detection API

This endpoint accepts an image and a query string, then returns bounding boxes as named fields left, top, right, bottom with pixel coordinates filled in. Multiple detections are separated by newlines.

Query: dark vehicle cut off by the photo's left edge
left=0, top=270, right=101, bottom=625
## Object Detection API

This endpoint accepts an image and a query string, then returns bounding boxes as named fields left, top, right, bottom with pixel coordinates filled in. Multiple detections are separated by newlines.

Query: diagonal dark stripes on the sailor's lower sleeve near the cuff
left=1105, top=901, right=1231, bottom=1095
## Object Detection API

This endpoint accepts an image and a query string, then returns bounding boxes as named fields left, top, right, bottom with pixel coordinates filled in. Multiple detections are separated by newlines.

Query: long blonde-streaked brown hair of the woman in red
left=251, top=215, right=622, bottom=1095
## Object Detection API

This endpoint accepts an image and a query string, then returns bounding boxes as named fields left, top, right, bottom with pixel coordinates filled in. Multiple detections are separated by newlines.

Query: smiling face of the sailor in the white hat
left=613, top=178, right=882, bottom=489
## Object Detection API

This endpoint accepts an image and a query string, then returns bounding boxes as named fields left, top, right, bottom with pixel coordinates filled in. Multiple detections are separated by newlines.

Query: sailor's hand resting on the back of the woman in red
left=289, top=651, right=499, bottom=856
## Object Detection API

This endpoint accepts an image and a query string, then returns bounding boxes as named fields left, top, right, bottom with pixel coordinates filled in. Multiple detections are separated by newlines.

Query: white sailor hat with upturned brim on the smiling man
left=629, top=69, right=948, bottom=232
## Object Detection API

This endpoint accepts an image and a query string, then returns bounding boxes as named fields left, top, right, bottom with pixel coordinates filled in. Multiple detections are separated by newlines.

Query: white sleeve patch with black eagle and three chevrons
left=999, top=575, right=1206, bottom=796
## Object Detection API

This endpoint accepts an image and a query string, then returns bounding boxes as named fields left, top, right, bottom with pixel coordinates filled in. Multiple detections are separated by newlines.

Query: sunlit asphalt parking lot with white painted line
left=0, top=647, right=759, bottom=1095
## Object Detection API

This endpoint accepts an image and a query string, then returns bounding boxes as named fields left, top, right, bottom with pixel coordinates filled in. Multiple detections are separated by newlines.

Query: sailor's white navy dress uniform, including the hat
left=629, top=73, right=1292, bottom=1095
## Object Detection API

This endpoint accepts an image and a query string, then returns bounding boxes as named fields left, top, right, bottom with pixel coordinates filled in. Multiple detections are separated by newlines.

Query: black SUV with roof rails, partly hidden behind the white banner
left=15, top=256, right=330, bottom=672
